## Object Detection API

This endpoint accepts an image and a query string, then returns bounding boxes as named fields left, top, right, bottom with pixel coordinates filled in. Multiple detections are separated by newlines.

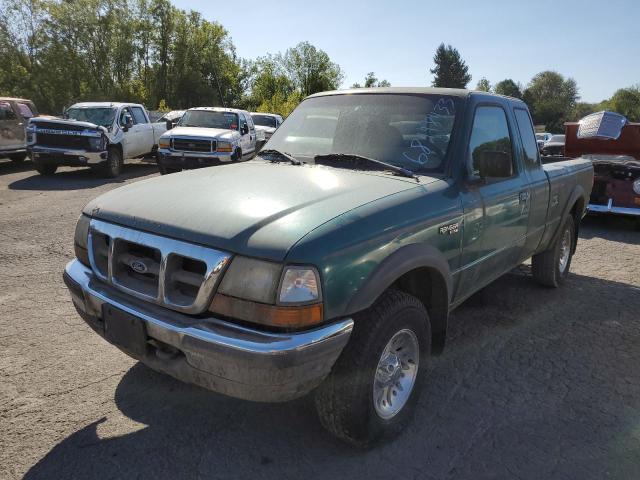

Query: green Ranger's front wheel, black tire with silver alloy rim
left=315, top=290, right=431, bottom=447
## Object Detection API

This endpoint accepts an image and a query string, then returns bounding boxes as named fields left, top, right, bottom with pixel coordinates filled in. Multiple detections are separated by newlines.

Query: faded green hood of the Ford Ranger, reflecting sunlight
left=84, top=161, right=435, bottom=261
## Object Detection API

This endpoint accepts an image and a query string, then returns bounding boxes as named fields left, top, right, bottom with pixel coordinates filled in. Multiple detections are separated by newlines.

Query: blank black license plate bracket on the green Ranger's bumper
left=102, top=304, right=148, bottom=356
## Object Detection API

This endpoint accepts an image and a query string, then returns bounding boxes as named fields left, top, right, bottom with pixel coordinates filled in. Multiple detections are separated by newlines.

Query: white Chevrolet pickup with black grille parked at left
left=27, top=102, right=167, bottom=177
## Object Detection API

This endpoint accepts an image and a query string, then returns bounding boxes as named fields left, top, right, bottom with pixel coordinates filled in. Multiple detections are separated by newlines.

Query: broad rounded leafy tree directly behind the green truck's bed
left=523, top=71, right=580, bottom=132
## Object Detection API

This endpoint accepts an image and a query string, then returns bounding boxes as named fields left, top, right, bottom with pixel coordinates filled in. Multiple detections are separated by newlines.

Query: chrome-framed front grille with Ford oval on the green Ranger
left=89, top=219, right=231, bottom=314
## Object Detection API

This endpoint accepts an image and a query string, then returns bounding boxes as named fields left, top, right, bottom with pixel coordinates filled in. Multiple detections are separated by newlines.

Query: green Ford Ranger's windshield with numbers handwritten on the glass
left=266, top=94, right=458, bottom=172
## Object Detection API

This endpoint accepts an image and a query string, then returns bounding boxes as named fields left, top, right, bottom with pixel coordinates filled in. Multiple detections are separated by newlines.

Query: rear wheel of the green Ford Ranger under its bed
left=531, top=217, right=575, bottom=288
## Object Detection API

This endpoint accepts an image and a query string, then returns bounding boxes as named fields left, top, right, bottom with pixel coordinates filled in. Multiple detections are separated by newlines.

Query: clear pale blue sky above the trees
left=172, top=0, right=640, bottom=102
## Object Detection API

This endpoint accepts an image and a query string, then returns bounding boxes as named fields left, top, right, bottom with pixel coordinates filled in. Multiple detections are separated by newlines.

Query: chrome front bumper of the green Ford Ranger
left=64, top=260, right=353, bottom=402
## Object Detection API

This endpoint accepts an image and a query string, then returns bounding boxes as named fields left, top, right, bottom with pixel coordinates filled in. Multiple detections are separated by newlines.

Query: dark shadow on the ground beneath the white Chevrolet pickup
left=9, top=163, right=158, bottom=190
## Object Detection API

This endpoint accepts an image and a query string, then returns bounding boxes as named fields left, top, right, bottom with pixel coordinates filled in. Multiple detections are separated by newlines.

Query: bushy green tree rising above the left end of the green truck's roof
left=276, top=42, right=344, bottom=97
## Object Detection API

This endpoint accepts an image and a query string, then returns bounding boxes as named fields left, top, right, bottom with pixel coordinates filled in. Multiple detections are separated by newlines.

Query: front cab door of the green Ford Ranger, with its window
left=459, top=104, right=530, bottom=296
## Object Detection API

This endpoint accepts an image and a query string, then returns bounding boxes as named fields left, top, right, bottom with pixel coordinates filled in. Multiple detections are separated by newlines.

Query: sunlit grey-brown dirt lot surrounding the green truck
left=0, top=161, right=640, bottom=480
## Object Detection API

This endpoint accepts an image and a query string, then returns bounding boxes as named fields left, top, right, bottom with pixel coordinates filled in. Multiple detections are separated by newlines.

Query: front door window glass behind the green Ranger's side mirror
left=467, top=106, right=516, bottom=177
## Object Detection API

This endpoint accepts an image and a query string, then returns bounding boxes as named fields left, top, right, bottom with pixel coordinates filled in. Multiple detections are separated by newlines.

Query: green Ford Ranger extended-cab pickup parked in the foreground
left=64, top=88, right=593, bottom=445
